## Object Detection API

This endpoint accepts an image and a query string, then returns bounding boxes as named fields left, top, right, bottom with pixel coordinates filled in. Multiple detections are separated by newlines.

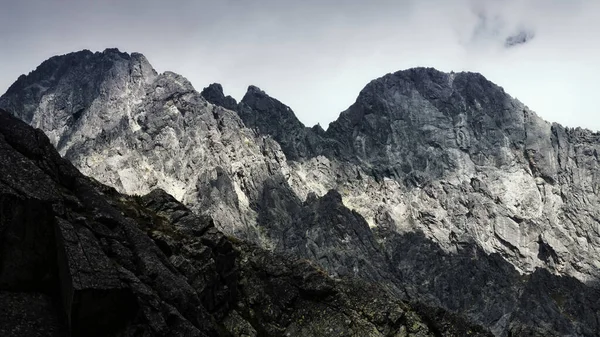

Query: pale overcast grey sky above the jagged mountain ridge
left=0, top=0, right=600, bottom=130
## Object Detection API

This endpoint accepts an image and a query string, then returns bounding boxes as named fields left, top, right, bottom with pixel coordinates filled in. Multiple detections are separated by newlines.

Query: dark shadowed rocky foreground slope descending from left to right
left=0, top=110, right=491, bottom=337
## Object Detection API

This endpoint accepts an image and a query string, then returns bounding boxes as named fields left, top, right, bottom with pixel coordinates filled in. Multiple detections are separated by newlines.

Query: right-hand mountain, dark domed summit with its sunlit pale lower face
left=242, top=68, right=600, bottom=280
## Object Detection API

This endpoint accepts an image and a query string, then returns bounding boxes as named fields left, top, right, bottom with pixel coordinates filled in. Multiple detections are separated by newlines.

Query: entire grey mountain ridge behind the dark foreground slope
left=0, top=49, right=600, bottom=336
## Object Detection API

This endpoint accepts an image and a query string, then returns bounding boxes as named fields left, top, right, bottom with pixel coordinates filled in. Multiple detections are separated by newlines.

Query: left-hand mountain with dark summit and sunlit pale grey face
left=0, top=50, right=286, bottom=245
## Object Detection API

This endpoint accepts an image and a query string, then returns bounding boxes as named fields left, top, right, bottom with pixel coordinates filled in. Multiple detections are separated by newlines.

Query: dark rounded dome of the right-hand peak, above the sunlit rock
left=327, top=68, right=550, bottom=180
